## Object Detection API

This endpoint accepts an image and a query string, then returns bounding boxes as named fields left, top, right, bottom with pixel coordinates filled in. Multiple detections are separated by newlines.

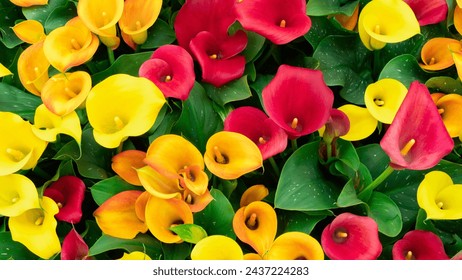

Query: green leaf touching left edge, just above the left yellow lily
left=0, top=83, right=42, bottom=122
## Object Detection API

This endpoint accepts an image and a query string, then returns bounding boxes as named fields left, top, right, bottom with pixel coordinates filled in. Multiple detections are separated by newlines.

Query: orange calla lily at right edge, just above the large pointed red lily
left=419, top=37, right=462, bottom=71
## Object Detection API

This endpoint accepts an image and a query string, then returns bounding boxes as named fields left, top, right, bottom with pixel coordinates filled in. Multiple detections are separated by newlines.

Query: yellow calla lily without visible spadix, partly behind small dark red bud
left=338, top=104, right=378, bottom=141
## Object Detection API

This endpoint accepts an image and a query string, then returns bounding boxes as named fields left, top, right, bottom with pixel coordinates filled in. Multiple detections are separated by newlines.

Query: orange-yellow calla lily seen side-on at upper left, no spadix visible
left=18, top=41, right=50, bottom=96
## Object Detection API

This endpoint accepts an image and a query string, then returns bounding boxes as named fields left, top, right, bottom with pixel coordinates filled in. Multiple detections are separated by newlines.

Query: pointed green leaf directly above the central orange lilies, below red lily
left=172, top=82, right=223, bottom=153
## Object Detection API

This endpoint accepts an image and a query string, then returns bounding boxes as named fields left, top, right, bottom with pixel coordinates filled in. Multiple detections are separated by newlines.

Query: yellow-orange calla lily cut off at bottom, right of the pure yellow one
left=264, top=232, right=324, bottom=260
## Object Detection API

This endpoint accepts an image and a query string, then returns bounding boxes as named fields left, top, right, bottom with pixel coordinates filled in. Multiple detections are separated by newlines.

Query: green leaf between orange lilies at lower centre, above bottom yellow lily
left=194, top=189, right=236, bottom=239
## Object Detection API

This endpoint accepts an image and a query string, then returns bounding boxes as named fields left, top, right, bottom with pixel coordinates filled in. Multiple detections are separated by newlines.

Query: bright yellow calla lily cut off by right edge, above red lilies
left=417, top=171, right=462, bottom=220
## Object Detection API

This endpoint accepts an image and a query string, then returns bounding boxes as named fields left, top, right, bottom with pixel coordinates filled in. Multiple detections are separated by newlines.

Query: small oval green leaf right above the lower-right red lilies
left=368, top=192, right=403, bottom=237
